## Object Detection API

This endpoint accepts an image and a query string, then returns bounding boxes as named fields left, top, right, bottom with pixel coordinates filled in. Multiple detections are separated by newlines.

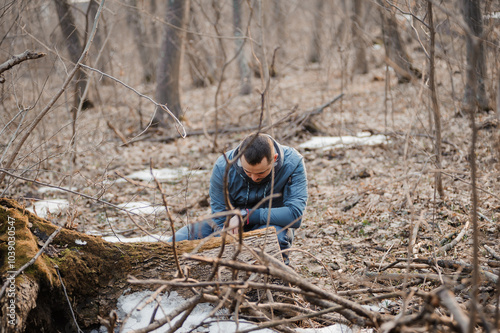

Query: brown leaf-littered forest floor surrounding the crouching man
left=4, top=55, right=500, bottom=326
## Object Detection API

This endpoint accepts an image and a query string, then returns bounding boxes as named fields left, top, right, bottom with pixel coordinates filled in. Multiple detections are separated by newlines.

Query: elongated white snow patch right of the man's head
left=299, top=132, right=389, bottom=150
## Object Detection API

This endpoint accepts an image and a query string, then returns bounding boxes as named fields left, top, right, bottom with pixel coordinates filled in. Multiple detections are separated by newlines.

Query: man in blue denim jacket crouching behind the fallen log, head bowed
left=170, top=133, right=307, bottom=261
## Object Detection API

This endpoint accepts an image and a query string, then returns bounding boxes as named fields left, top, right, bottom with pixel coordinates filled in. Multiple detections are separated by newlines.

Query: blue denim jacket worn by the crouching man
left=209, top=136, right=307, bottom=228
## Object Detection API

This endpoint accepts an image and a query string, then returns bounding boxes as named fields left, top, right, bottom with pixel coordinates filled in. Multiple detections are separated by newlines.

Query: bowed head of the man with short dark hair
left=240, top=134, right=278, bottom=183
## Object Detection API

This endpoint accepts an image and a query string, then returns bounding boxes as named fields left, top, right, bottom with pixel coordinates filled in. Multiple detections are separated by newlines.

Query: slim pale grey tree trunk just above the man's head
left=233, top=0, right=252, bottom=95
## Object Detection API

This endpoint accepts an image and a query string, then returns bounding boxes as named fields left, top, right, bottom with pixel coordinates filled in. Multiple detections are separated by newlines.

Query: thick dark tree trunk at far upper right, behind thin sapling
left=462, top=0, right=491, bottom=110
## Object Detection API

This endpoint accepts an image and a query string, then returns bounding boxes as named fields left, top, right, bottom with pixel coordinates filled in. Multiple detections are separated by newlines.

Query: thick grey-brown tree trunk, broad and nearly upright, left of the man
left=153, top=0, right=189, bottom=128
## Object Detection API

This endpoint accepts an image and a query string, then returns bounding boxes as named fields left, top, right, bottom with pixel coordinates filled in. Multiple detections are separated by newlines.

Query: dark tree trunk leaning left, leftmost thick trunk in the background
left=54, top=0, right=87, bottom=111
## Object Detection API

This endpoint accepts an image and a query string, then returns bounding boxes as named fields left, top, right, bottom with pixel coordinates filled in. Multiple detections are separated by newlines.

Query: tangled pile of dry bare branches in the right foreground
left=130, top=244, right=498, bottom=332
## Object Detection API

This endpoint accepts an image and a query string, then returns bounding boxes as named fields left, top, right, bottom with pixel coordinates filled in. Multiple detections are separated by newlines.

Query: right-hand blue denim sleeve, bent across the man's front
left=249, top=160, right=307, bottom=228
